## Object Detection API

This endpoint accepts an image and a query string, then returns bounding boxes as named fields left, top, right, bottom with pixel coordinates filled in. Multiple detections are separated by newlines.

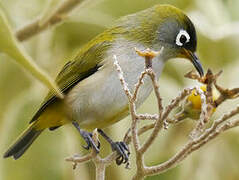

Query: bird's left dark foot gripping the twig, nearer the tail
left=80, top=130, right=100, bottom=153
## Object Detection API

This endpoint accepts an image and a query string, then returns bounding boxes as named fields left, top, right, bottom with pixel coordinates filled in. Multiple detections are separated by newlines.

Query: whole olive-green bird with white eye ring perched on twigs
left=4, top=5, right=203, bottom=161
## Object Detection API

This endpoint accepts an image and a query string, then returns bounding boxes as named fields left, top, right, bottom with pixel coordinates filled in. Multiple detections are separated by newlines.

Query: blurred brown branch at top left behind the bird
left=16, top=0, right=82, bottom=41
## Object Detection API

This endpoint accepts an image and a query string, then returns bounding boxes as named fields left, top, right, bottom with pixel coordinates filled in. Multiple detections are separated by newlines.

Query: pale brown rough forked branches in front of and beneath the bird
left=67, top=49, right=239, bottom=180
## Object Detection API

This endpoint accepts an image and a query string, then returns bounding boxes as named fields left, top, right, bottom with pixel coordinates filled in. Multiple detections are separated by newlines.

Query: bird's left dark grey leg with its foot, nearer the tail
left=72, top=121, right=100, bottom=153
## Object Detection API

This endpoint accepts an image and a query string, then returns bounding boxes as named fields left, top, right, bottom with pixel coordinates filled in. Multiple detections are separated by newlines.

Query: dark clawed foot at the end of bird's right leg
left=111, top=141, right=130, bottom=165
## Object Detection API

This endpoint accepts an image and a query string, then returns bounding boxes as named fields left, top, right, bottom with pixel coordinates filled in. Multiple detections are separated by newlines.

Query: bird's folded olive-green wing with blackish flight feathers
left=30, top=28, right=118, bottom=123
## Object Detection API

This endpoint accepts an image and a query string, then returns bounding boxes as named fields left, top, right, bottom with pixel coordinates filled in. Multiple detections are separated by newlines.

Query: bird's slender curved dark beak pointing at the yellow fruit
left=184, top=49, right=204, bottom=77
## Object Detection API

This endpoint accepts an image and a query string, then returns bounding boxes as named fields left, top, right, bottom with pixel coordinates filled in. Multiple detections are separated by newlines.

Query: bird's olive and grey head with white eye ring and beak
left=123, top=5, right=203, bottom=76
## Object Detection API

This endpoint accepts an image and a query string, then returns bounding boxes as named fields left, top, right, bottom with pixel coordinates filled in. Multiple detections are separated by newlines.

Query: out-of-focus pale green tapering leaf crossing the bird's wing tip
left=0, top=6, right=63, bottom=97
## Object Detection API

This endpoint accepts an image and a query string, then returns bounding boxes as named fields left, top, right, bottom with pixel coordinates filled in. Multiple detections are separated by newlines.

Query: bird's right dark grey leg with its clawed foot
left=97, top=129, right=130, bottom=165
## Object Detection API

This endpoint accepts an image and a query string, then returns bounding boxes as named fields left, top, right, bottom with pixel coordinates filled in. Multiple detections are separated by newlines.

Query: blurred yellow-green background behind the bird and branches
left=0, top=0, right=239, bottom=180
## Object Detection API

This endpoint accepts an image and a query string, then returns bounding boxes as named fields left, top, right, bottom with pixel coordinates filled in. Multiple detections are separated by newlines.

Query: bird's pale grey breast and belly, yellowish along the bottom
left=67, top=41, right=163, bottom=129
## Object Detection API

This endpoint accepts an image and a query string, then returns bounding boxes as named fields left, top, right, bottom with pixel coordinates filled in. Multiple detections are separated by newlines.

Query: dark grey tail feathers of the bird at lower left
left=3, top=125, right=43, bottom=159
